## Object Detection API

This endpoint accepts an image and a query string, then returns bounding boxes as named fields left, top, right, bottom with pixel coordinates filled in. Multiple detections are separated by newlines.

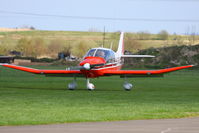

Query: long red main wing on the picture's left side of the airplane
left=0, top=64, right=83, bottom=77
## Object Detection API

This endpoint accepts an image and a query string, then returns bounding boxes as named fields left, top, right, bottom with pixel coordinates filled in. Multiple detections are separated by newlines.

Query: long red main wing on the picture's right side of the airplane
left=104, top=65, right=193, bottom=77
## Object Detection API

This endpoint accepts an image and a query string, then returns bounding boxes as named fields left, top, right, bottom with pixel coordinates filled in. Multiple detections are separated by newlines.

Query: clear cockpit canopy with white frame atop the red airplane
left=84, top=48, right=115, bottom=62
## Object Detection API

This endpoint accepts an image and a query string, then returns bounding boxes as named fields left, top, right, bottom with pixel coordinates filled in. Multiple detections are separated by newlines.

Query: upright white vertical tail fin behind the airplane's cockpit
left=116, top=32, right=124, bottom=57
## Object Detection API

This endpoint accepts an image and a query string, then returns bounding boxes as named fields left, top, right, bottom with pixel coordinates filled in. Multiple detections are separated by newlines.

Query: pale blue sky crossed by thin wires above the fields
left=0, top=0, right=199, bottom=34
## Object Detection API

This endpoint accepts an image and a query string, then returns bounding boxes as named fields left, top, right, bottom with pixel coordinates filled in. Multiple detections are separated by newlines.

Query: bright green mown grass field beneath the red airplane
left=0, top=66, right=199, bottom=125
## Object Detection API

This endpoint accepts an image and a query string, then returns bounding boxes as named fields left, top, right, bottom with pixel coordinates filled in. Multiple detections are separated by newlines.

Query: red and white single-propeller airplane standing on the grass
left=0, top=32, right=193, bottom=91
